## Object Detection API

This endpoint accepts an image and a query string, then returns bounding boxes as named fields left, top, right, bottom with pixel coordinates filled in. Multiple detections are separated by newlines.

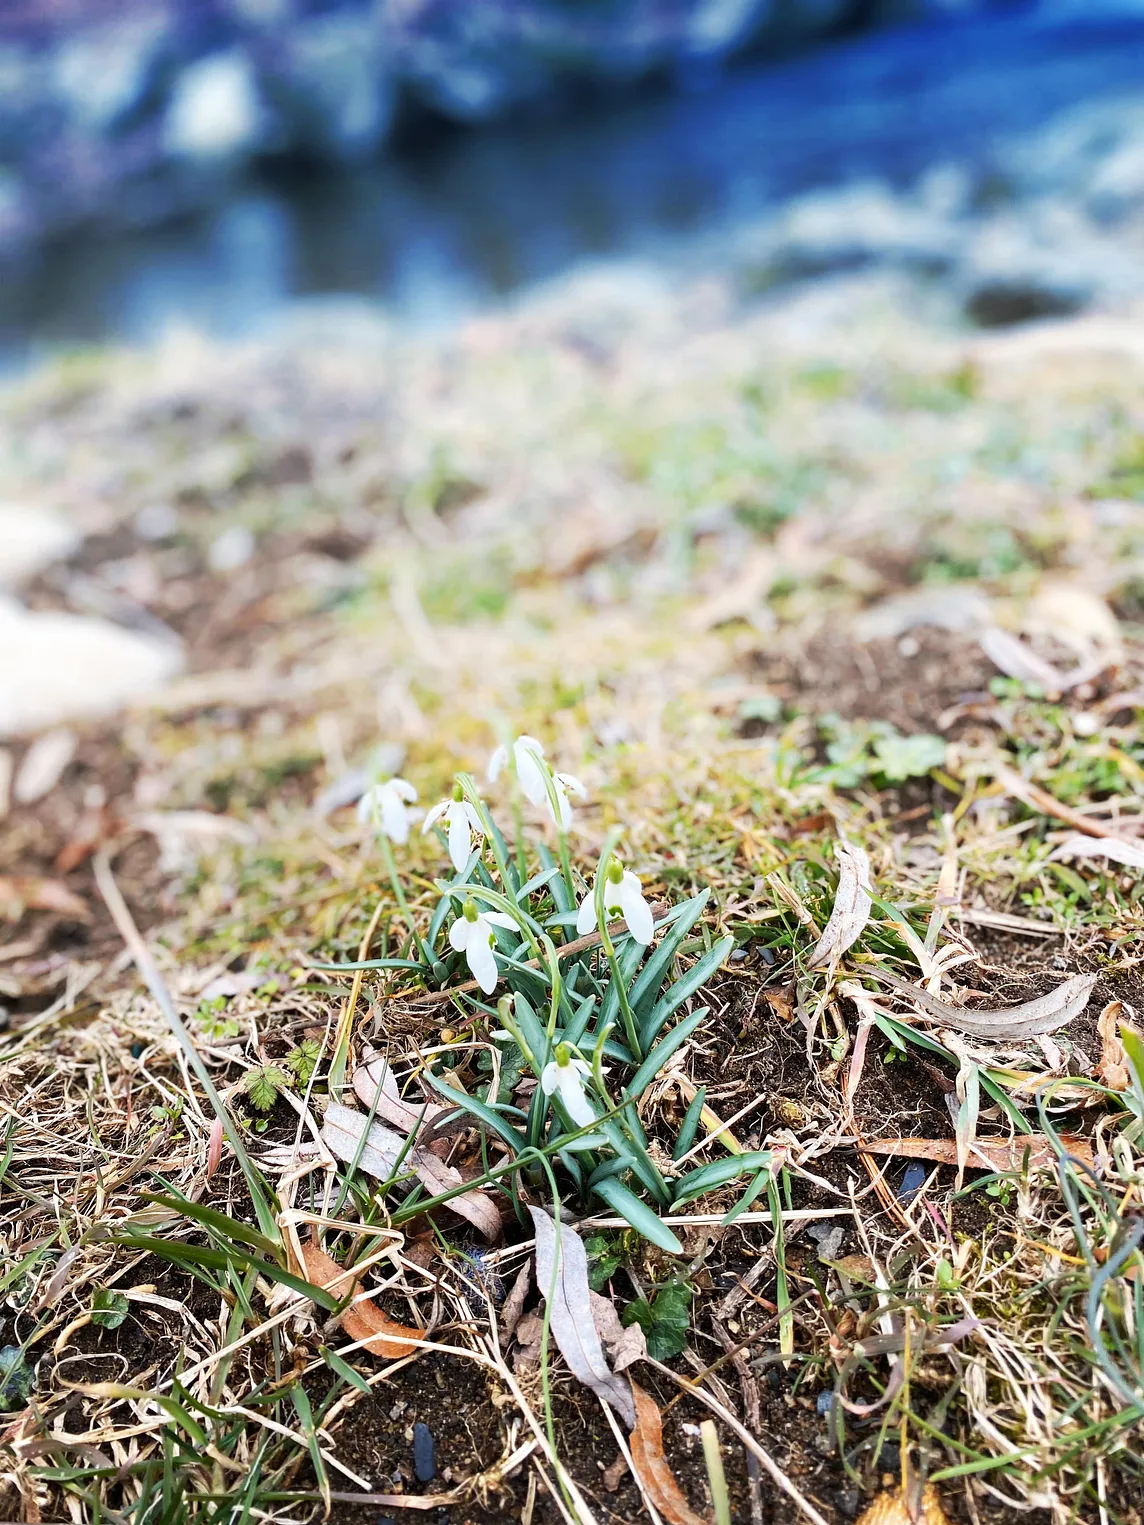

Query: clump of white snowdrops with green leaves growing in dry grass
left=340, top=735, right=756, bottom=1254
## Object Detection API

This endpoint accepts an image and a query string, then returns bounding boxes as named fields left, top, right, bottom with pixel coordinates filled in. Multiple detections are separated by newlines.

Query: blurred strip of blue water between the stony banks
left=0, top=8, right=1144, bottom=369
